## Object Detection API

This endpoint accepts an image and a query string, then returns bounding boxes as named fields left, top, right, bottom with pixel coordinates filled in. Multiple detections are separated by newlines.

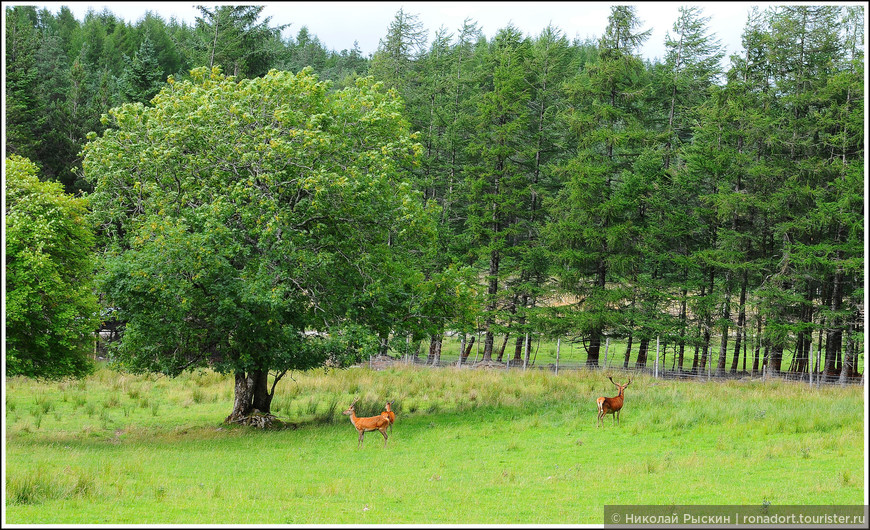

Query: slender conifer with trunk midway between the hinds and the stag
left=466, top=25, right=531, bottom=362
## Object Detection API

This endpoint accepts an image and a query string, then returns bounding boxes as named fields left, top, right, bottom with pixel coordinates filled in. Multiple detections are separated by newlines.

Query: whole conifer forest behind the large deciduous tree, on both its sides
left=6, top=5, right=864, bottom=390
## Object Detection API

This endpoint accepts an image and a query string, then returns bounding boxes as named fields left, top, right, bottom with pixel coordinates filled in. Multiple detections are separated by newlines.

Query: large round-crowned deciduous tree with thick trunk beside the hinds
left=84, top=68, right=433, bottom=421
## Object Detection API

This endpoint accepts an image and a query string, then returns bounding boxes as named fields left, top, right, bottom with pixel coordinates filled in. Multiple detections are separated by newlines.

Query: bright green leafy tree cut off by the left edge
left=5, top=155, right=99, bottom=379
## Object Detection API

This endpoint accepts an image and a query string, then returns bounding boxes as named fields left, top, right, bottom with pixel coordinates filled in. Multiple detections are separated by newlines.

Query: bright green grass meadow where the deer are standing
left=5, top=367, right=866, bottom=524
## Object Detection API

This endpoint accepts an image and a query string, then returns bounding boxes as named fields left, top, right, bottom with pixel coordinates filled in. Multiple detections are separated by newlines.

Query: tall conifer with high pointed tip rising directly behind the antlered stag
left=545, top=6, right=658, bottom=364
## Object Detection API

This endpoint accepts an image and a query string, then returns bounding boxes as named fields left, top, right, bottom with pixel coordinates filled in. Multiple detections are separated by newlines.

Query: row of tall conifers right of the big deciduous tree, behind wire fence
left=369, top=6, right=864, bottom=379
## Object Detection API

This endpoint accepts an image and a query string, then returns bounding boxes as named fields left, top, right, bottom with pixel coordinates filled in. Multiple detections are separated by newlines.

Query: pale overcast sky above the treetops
left=29, top=1, right=857, bottom=62
